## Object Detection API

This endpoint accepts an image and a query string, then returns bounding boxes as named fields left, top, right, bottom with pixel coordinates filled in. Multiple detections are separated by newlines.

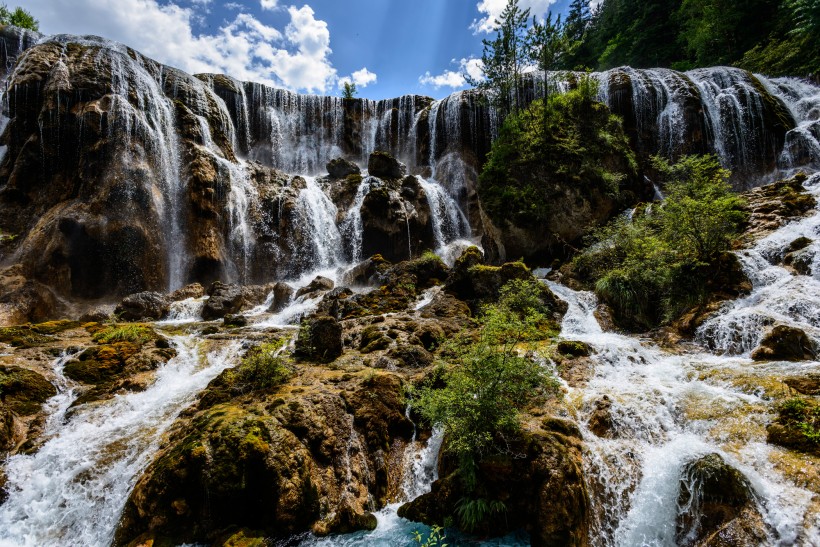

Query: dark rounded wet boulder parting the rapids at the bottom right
left=676, top=453, right=766, bottom=546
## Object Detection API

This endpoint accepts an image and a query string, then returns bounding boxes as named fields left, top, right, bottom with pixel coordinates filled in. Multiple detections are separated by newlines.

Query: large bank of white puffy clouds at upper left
left=26, top=0, right=337, bottom=93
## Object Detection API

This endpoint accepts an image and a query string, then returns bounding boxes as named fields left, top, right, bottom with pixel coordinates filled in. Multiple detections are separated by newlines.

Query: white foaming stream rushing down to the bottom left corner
left=0, top=337, right=240, bottom=547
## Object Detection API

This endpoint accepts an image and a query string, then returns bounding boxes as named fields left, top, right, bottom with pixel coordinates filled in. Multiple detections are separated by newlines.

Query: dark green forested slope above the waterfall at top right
left=557, top=0, right=820, bottom=76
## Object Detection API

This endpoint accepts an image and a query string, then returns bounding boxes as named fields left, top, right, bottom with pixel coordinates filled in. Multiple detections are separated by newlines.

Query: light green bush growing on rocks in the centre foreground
left=412, top=280, right=557, bottom=474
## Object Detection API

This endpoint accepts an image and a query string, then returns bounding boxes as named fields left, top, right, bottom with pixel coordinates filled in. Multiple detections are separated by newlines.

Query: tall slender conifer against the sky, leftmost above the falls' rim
left=467, top=0, right=530, bottom=119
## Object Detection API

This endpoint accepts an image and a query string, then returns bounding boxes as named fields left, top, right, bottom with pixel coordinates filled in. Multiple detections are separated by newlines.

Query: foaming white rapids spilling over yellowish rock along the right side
left=550, top=176, right=820, bottom=546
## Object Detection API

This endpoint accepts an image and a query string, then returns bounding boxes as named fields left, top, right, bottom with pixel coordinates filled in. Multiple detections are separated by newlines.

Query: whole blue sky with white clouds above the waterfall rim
left=25, top=0, right=569, bottom=99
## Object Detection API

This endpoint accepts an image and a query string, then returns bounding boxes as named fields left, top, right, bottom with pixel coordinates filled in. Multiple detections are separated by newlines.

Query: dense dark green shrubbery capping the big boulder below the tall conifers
left=479, top=75, right=637, bottom=224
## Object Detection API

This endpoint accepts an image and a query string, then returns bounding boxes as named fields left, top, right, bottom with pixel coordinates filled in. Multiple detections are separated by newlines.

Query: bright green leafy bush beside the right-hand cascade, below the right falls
left=574, top=156, right=745, bottom=329
